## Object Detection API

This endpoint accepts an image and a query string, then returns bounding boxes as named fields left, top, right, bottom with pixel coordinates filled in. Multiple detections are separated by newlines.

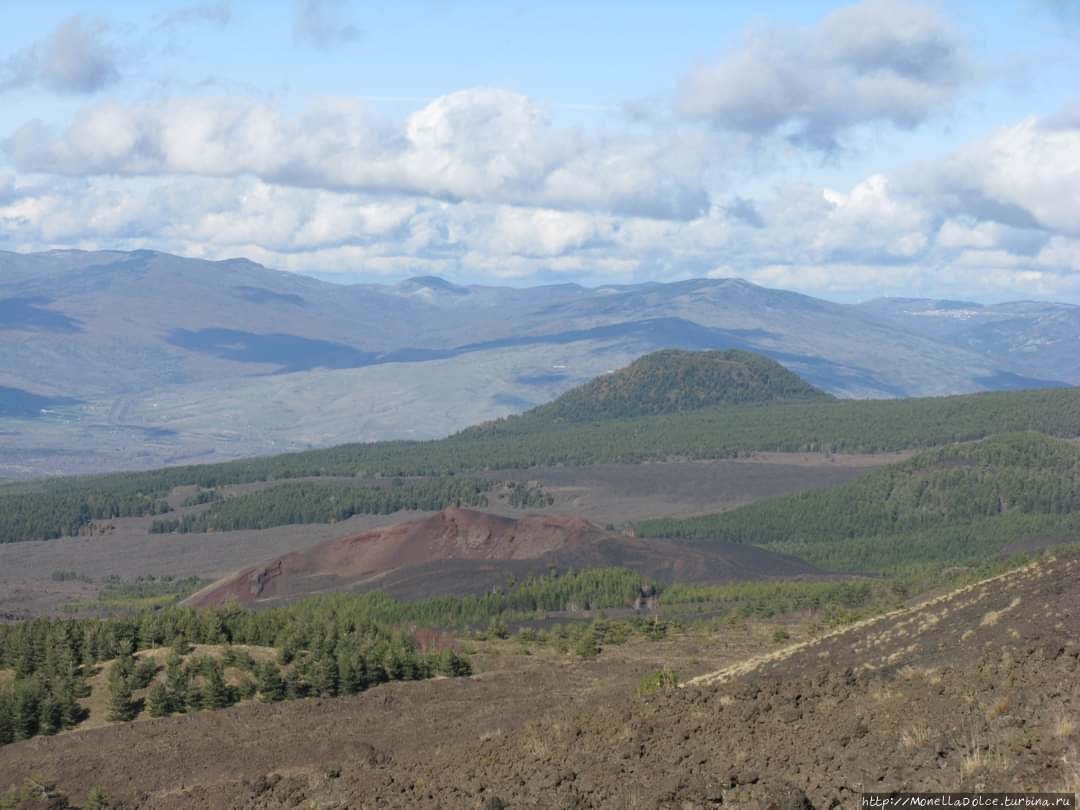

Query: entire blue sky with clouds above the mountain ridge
left=0, top=0, right=1080, bottom=302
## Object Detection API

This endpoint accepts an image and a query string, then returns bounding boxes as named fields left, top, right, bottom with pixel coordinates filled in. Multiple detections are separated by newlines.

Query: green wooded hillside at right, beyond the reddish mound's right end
left=637, top=432, right=1080, bottom=570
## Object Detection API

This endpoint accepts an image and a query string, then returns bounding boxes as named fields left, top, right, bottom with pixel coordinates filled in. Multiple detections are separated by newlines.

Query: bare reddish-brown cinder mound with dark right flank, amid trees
left=188, top=509, right=821, bottom=607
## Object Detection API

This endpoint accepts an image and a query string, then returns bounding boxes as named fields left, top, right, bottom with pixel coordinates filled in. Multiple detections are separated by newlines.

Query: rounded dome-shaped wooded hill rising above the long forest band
left=479, top=349, right=833, bottom=427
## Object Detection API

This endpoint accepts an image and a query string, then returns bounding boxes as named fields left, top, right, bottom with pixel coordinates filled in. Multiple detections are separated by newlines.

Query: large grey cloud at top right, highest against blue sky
left=675, top=0, right=969, bottom=148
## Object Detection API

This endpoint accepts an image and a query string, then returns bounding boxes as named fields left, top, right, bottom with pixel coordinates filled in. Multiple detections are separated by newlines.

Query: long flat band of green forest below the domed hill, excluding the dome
left=6, top=389, right=1080, bottom=542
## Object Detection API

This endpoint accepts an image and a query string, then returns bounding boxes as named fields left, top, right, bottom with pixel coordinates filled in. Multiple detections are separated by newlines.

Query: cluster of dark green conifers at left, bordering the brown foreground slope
left=0, top=604, right=471, bottom=745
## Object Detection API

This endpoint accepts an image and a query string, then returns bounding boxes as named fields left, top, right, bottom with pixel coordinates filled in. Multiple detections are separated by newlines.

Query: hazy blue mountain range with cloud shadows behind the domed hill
left=0, top=251, right=1080, bottom=475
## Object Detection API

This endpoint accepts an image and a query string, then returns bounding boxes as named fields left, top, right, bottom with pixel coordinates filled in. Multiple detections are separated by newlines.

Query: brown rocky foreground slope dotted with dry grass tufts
left=0, top=557, right=1080, bottom=810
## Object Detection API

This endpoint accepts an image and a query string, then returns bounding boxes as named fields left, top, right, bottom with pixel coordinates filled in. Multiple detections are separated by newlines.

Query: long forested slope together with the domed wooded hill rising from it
left=0, top=352, right=1080, bottom=542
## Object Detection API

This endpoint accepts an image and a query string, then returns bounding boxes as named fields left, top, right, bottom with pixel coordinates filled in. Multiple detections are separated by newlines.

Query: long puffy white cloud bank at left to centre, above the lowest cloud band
left=4, top=89, right=715, bottom=218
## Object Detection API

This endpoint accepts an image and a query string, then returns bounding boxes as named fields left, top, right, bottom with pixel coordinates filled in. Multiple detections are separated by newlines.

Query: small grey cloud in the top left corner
left=0, top=17, right=120, bottom=94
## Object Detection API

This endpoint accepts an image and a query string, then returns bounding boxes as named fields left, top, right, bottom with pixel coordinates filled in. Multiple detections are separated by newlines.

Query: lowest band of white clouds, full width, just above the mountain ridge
left=0, top=149, right=1080, bottom=298
